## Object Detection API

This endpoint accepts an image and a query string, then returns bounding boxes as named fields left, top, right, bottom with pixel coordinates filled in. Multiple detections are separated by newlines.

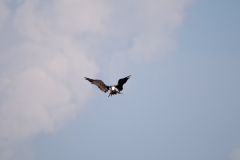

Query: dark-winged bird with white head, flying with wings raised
left=84, top=75, right=131, bottom=97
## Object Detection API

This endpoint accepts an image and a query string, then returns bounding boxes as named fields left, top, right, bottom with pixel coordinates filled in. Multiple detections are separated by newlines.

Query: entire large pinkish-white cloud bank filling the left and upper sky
left=0, top=0, right=190, bottom=160
